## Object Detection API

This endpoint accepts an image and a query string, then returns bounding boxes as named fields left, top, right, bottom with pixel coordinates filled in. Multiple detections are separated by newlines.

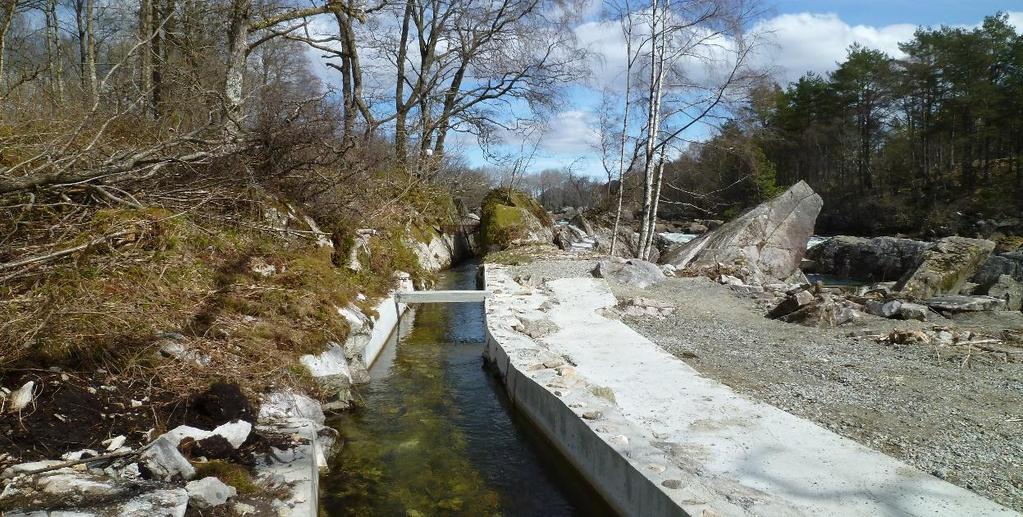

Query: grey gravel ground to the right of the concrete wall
left=501, top=260, right=1023, bottom=511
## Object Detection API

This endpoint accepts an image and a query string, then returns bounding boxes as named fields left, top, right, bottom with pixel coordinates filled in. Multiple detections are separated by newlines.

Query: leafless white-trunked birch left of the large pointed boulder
left=597, top=0, right=759, bottom=259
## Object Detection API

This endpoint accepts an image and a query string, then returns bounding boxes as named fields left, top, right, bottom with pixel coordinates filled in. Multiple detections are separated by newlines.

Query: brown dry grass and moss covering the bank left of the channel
left=0, top=185, right=456, bottom=398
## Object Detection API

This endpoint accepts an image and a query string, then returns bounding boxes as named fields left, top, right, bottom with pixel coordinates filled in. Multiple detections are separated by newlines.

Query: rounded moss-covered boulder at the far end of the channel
left=480, top=188, right=554, bottom=252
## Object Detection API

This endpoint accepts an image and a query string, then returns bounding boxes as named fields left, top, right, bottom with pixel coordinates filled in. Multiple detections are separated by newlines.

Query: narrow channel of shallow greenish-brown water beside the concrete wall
left=320, top=264, right=614, bottom=517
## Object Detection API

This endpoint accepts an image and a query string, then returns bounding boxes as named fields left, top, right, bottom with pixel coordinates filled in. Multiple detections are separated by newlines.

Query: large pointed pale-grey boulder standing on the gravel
left=661, top=181, right=824, bottom=282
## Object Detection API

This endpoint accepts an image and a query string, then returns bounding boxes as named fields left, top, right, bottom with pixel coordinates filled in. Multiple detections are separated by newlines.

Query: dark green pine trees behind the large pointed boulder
left=665, top=13, right=1023, bottom=233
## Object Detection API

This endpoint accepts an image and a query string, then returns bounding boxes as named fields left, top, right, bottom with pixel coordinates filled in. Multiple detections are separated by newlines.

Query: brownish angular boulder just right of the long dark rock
left=895, top=236, right=994, bottom=298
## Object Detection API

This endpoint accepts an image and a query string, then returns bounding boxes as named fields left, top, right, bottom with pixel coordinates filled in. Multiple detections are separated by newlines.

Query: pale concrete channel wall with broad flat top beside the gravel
left=485, top=264, right=1019, bottom=517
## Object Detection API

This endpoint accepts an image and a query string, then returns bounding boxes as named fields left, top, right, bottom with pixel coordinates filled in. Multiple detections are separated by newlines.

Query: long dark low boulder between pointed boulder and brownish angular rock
left=806, top=235, right=932, bottom=282
